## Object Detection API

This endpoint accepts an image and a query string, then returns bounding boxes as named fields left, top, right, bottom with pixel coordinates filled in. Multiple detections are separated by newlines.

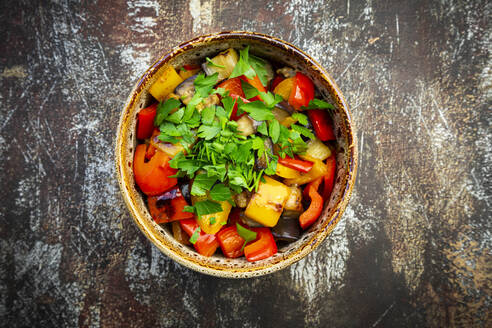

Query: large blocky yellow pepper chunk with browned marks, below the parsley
left=244, top=176, right=290, bottom=227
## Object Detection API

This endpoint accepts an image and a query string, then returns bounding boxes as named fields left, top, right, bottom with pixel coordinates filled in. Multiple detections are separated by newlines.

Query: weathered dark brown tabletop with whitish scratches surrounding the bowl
left=0, top=0, right=492, bottom=327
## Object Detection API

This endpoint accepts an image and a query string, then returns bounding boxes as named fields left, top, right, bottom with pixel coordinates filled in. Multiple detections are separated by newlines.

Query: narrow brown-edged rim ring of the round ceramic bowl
left=115, top=31, right=358, bottom=278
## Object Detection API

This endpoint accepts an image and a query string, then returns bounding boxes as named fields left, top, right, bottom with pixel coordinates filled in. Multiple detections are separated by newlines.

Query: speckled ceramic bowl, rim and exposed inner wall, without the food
left=116, top=32, right=357, bottom=278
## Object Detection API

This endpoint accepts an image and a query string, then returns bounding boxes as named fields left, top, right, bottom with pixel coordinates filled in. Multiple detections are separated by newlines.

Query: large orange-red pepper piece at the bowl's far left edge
left=133, top=144, right=178, bottom=196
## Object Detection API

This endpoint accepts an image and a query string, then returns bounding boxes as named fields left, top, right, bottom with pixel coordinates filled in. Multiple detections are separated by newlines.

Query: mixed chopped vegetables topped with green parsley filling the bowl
left=133, top=47, right=336, bottom=261
